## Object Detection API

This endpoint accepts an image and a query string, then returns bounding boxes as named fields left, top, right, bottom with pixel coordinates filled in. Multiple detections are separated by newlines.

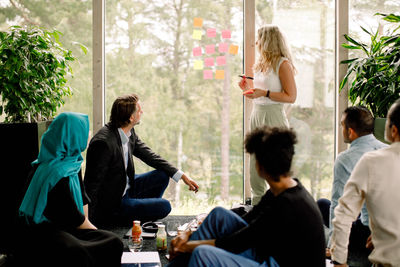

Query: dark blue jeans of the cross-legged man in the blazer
left=118, top=170, right=171, bottom=223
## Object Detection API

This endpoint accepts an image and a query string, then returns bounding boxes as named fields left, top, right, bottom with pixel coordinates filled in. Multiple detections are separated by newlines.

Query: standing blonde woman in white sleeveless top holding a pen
left=239, top=25, right=297, bottom=205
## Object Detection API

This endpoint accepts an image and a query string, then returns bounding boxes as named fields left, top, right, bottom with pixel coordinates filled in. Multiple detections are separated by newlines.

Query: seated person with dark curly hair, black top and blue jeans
left=168, top=127, right=325, bottom=267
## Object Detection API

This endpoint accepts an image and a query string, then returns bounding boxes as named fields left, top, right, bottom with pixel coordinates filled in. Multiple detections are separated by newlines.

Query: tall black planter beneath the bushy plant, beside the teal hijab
left=0, top=121, right=51, bottom=253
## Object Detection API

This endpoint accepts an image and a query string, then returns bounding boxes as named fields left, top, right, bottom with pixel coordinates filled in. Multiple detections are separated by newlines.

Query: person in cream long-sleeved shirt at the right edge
left=331, top=100, right=400, bottom=266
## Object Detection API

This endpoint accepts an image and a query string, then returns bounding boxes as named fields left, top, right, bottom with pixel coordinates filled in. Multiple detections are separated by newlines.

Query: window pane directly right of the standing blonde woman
left=256, top=0, right=335, bottom=199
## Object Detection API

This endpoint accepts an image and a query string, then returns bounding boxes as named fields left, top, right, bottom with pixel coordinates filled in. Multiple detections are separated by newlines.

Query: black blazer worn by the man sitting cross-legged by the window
left=84, top=123, right=178, bottom=225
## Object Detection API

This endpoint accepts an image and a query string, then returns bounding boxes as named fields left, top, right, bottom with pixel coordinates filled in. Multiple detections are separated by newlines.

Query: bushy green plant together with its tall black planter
left=0, top=26, right=81, bottom=252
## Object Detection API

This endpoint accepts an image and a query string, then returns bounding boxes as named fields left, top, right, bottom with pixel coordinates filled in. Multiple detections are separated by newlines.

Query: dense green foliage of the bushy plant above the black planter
left=0, top=26, right=79, bottom=122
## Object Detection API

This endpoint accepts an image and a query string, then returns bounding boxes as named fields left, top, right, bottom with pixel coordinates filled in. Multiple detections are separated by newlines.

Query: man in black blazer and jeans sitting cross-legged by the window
left=84, top=94, right=199, bottom=226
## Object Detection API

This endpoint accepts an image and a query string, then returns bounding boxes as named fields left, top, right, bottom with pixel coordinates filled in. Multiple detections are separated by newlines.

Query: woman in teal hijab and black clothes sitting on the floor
left=19, top=112, right=123, bottom=266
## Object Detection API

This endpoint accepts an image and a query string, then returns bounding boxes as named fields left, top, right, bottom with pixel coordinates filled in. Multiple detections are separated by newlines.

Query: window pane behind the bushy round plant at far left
left=0, top=0, right=92, bottom=123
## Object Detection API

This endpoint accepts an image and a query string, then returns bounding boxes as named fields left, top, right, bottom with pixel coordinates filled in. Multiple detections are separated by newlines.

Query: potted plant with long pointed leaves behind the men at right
left=340, top=13, right=400, bottom=141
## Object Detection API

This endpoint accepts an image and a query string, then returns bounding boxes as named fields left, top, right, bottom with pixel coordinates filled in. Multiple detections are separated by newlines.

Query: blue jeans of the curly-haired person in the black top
left=167, top=207, right=279, bottom=267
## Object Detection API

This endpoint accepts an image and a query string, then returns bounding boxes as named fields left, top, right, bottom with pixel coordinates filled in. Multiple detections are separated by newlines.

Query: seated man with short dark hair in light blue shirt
left=324, top=106, right=387, bottom=267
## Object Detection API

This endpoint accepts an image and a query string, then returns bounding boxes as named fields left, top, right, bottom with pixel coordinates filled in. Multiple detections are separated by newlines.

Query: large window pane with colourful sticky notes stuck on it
left=106, top=0, right=243, bottom=214
